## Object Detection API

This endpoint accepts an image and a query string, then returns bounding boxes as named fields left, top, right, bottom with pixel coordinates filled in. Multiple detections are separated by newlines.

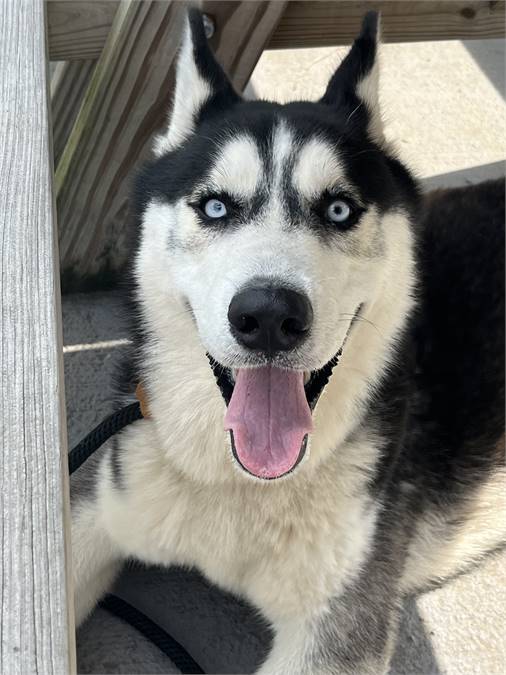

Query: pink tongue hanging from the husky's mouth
left=225, top=366, right=313, bottom=478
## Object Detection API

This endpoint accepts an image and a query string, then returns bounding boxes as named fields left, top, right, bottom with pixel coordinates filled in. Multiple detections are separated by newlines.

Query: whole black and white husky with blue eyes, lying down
left=72, top=9, right=505, bottom=675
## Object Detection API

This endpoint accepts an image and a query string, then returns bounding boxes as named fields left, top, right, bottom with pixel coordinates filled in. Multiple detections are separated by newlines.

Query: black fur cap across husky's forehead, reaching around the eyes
left=134, top=101, right=418, bottom=246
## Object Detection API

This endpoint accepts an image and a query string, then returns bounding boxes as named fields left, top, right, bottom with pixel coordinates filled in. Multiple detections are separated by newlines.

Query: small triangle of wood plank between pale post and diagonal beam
left=51, top=61, right=96, bottom=166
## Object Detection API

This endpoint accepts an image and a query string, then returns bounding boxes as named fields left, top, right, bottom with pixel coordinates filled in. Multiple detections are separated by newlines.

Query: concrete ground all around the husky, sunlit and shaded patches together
left=63, top=40, right=506, bottom=675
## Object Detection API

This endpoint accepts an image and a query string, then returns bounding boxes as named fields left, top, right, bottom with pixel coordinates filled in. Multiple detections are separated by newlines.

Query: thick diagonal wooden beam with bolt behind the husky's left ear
left=56, top=0, right=284, bottom=291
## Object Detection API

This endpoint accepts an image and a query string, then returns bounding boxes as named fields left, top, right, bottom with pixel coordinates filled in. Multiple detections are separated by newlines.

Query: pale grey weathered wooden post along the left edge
left=0, top=0, right=75, bottom=675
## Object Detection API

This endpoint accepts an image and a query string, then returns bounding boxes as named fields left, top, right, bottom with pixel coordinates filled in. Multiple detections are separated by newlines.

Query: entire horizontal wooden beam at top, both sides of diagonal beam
left=48, top=0, right=505, bottom=60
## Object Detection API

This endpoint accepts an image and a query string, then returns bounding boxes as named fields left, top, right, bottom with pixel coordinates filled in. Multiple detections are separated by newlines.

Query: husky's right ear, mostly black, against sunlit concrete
left=321, top=12, right=385, bottom=144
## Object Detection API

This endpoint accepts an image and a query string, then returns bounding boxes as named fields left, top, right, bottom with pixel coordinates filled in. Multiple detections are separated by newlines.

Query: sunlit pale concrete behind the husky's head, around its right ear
left=248, top=40, right=506, bottom=186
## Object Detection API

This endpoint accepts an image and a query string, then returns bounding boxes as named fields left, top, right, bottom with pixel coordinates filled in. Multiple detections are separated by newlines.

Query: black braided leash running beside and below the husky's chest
left=68, top=401, right=205, bottom=675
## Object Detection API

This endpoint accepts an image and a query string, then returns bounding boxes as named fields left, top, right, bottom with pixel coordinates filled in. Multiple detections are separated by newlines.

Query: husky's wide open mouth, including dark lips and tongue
left=208, top=306, right=361, bottom=480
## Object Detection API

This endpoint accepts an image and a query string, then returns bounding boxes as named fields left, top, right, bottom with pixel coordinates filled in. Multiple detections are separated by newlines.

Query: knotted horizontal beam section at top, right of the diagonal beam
left=269, top=0, right=506, bottom=49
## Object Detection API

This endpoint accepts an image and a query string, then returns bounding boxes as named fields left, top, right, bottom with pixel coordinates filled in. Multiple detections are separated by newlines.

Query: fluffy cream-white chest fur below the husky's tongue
left=98, top=420, right=377, bottom=619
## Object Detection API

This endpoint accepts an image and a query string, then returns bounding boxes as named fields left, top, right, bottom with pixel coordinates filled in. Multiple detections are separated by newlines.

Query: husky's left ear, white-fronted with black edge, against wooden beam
left=154, top=7, right=240, bottom=155
